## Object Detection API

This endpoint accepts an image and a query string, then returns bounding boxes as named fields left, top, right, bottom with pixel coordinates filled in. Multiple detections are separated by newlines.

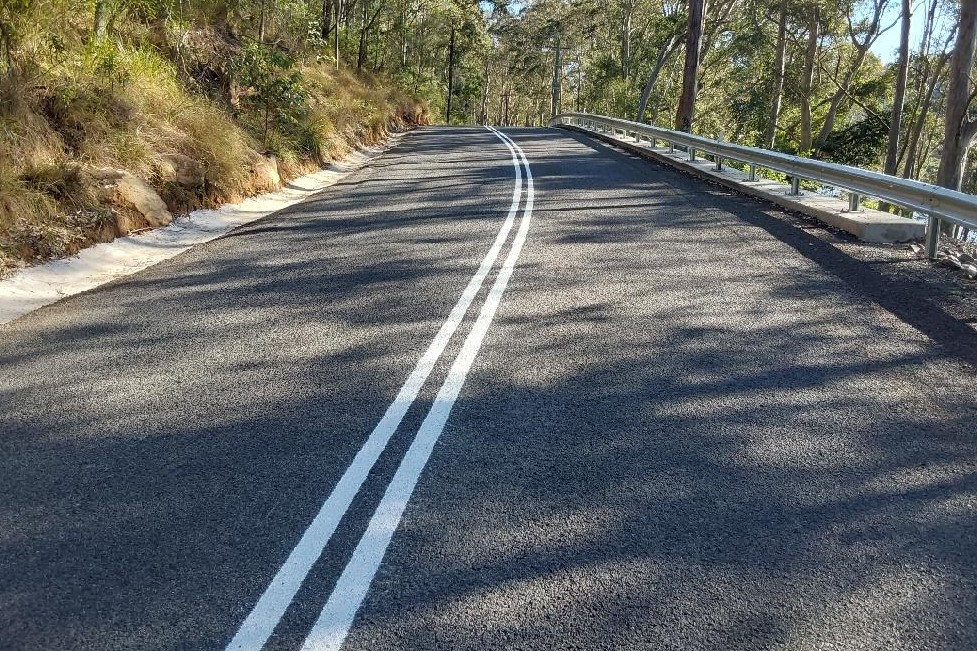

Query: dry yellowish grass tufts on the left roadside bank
left=0, top=25, right=427, bottom=277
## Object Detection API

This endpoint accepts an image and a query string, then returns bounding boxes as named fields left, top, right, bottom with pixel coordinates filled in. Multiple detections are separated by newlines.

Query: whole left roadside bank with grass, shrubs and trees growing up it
left=0, top=0, right=438, bottom=275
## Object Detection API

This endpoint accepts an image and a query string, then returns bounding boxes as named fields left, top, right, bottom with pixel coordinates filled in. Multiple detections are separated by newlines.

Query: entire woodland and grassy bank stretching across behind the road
left=0, top=0, right=977, bottom=268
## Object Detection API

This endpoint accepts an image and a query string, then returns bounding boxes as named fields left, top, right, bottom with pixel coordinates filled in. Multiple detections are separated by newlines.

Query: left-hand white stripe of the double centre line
left=226, top=130, right=522, bottom=651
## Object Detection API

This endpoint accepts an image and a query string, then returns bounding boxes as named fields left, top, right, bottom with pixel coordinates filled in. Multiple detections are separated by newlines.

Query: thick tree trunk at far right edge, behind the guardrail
left=936, top=0, right=977, bottom=190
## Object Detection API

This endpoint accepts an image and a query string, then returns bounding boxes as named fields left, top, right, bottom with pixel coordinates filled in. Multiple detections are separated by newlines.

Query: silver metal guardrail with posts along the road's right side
left=550, top=113, right=977, bottom=258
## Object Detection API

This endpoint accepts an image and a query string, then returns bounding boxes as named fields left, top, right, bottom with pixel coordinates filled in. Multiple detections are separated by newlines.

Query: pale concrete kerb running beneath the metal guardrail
left=559, top=124, right=926, bottom=243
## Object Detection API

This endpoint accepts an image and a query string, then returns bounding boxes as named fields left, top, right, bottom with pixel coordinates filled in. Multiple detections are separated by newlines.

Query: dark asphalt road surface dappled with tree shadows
left=0, top=128, right=977, bottom=651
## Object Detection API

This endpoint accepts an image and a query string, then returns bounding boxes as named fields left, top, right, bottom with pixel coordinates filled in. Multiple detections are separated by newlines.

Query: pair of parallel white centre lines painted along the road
left=227, top=127, right=534, bottom=651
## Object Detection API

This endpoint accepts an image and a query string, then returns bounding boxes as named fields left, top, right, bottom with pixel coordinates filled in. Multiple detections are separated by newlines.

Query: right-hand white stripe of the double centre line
left=302, top=127, right=534, bottom=651
